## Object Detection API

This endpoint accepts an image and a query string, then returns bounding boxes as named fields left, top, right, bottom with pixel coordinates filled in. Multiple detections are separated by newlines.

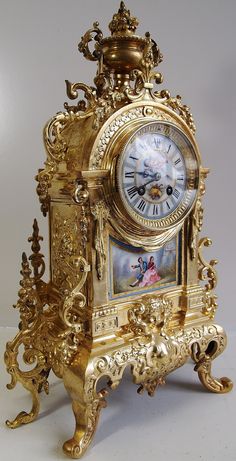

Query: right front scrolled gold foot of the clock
left=192, top=342, right=233, bottom=394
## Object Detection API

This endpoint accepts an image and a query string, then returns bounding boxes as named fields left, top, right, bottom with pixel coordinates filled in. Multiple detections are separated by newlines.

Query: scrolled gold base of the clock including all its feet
left=5, top=319, right=233, bottom=458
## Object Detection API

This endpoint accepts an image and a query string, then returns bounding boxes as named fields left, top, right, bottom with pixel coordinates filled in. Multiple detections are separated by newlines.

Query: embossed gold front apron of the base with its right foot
left=79, top=324, right=232, bottom=408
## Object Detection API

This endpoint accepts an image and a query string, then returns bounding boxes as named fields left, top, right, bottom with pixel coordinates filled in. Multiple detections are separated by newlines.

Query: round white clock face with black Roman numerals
left=117, top=122, right=198, bottom=227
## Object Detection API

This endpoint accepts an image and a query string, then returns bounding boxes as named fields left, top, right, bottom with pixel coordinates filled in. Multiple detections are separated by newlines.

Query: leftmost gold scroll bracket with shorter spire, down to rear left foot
left=4, top=246, right=50, bottom=428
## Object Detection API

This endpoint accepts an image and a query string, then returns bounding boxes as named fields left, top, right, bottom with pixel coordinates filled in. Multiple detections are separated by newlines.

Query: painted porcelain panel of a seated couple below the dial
left=109, top=237, right=179, bottom=298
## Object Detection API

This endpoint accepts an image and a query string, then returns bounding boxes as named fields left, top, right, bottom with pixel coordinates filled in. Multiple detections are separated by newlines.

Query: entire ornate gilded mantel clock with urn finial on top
left=5, top=2, right=232, bottom=458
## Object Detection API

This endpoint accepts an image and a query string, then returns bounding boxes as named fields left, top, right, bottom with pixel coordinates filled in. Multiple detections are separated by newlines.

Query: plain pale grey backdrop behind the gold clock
left=0, top=0, right=236, bottom=330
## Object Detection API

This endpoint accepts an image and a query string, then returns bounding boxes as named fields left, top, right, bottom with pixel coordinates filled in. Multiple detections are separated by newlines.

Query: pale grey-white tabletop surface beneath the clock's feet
left=0, top=328, right=236, bottom=461
